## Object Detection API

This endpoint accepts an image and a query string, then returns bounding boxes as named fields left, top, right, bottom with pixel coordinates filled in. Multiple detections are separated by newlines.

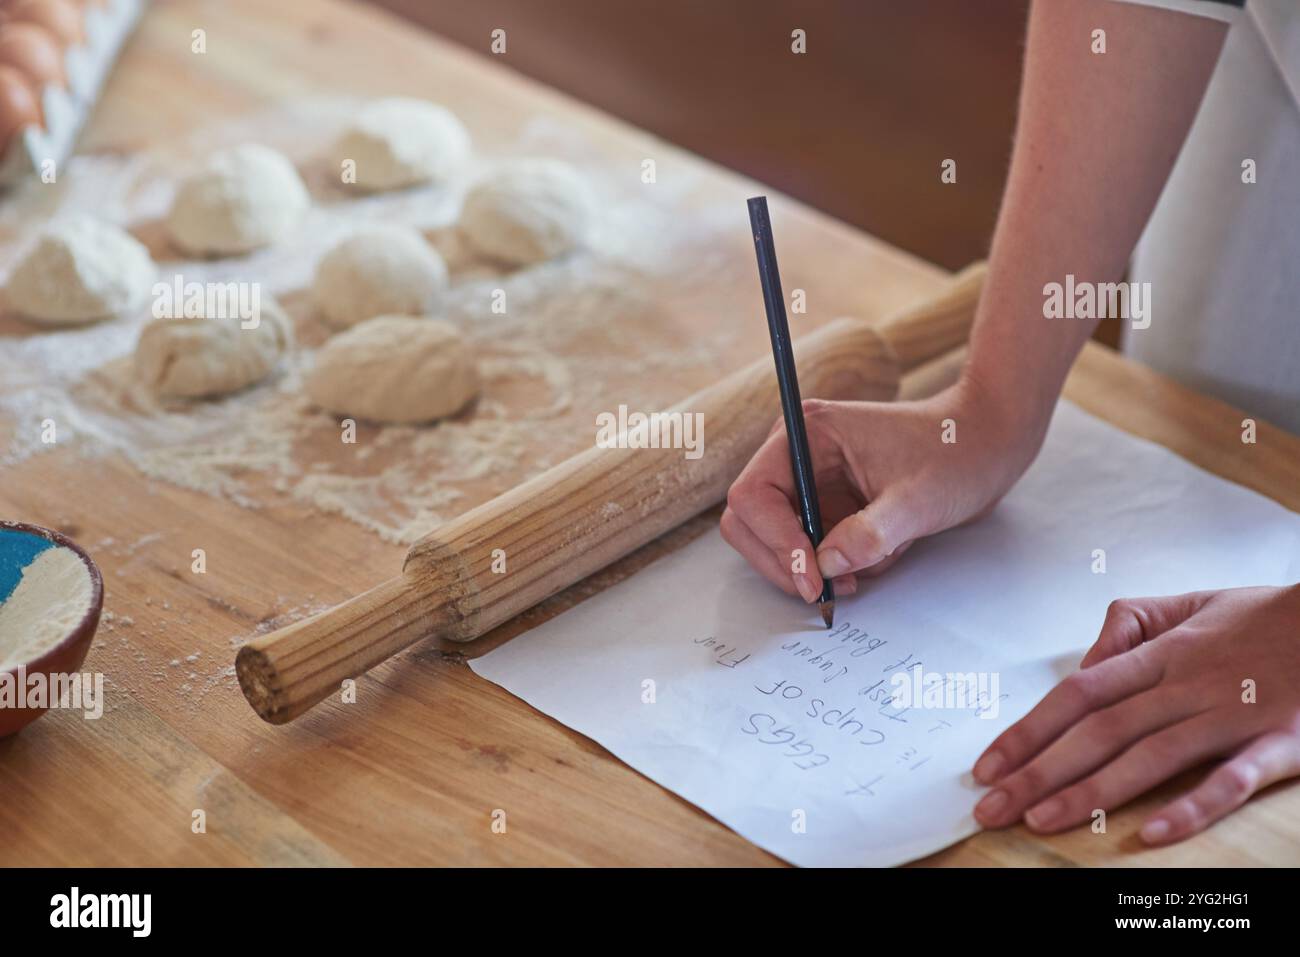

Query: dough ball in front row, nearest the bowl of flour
left=135, top=302, right=294, bottom=398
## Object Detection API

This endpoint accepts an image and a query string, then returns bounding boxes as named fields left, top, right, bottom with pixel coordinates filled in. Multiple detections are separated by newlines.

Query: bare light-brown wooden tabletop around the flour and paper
left=0, top=0, right=1300, bottom=865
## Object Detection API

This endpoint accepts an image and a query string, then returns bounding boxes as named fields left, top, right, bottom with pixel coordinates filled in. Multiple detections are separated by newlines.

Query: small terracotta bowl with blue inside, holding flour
left=0, top=521, right=104, bottom=737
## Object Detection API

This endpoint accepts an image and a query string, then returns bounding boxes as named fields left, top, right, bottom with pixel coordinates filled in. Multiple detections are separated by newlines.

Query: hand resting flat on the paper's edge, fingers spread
left=974, top=585, right=1300, bottom=844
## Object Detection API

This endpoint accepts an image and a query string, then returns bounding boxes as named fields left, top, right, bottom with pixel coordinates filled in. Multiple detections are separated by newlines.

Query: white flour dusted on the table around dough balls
left=0, top=99, right=754, bottom=542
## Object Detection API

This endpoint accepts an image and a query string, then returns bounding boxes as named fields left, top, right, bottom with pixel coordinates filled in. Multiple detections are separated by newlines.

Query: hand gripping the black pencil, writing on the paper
left=722, top=382, right=1041, bottom=602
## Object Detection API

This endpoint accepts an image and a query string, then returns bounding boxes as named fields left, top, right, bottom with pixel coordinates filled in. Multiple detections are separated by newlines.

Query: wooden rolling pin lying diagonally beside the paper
left=235, top=257, right=984, bottom=724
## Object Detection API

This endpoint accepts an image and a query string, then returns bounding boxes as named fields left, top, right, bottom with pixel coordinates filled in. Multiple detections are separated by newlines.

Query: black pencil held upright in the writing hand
left=749, top=196, right=835, bottom=628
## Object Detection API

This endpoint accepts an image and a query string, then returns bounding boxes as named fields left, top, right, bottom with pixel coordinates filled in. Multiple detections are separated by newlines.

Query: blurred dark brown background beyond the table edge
left=372, top=0, right=1028, bottom=276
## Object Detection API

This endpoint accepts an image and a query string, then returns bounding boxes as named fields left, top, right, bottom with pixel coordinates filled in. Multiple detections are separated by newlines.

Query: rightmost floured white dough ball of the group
left=460, top=160, right=595, bottom=265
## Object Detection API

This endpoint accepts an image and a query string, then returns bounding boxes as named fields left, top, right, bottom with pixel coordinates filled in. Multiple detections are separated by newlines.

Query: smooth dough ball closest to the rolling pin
left=304, top=316, right=478, bottom=424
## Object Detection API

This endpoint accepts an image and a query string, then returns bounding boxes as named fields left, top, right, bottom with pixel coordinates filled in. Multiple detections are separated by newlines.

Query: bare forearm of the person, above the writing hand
left=963, top=0, right=1226, bottom=438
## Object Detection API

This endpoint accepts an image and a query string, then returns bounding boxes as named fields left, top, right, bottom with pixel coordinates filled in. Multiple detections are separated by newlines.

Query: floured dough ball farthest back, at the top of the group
left=333, top=96, right=469, bottom=190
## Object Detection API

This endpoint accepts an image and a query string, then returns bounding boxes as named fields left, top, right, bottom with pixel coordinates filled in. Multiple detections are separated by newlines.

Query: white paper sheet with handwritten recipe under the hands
left=471, top=402, right=1300, bottom=866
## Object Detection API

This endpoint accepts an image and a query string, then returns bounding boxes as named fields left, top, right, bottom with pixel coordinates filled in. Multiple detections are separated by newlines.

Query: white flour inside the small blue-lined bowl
left=0, top=546, right=94, bottom=671
